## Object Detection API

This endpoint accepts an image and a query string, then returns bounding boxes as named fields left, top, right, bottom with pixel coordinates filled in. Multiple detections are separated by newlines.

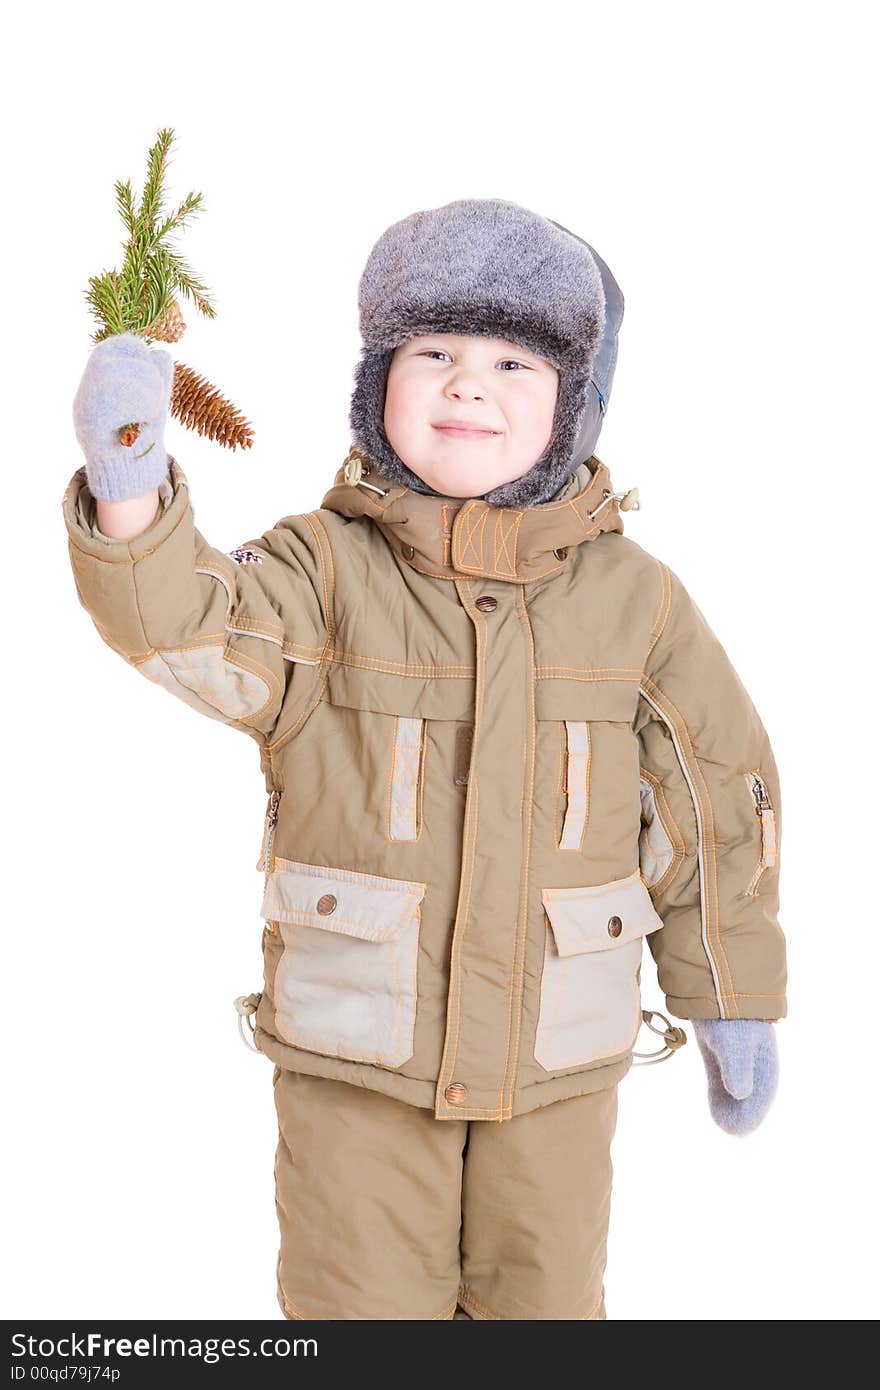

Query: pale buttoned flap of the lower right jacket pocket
left=541, top=869, right=663, bottom=955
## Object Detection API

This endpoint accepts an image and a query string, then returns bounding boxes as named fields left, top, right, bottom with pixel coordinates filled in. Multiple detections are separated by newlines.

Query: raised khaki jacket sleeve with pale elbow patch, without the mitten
left=63, top=457, right=329, bottom=741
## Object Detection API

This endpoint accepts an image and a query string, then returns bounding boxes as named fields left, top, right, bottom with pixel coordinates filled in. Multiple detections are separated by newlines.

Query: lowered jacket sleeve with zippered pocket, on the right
left=634, top=564, right=787, bottom=1019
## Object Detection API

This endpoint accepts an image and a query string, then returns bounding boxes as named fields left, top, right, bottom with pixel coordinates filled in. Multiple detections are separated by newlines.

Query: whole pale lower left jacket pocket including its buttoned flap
left=263, top=856, right=425, bottom=1066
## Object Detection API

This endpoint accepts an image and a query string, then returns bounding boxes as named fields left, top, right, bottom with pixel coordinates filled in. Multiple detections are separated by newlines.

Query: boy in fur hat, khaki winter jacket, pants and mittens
left=64, top=199, right=785, bottom=1321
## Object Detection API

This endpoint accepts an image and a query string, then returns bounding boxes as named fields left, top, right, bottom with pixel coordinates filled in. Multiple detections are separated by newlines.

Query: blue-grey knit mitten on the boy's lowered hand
left=692, top=1019, right=779, bottom=1134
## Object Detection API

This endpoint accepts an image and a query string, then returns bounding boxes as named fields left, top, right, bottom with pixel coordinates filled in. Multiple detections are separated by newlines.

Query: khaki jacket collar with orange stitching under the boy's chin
left=321, top=446, right=638, bottom=584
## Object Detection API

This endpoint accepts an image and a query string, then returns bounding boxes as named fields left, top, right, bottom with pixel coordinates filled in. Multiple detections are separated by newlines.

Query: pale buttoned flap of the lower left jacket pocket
left=260, top=856, right=427, bottom=941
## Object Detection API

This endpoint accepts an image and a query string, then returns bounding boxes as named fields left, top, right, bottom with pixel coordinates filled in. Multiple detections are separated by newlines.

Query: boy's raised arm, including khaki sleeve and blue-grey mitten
left=63, top=334, right=331, bottom=738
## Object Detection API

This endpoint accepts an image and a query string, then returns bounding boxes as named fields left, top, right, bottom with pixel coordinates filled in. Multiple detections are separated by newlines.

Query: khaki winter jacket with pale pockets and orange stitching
left=63, top=449, right=785, bottom=1120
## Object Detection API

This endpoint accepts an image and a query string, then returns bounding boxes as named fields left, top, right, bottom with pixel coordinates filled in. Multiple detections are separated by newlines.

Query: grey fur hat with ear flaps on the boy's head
left=349, top=197, right=623, bottom=507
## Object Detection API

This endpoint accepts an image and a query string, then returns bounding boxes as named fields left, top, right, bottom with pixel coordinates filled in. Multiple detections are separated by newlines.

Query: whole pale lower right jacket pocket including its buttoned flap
left=535, top=869, right=663, bottom=1072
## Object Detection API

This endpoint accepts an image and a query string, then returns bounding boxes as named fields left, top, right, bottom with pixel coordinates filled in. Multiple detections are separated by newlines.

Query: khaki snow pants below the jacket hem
left=274, top=1066, right=617, bottom=1321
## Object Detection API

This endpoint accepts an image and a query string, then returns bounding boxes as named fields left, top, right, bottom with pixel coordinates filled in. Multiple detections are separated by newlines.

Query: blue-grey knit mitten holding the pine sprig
left=74, top=334, right=174, bottom=502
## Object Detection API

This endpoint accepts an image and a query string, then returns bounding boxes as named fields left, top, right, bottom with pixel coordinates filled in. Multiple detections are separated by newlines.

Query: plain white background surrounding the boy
left=0, top=0, right=880, bottom=1336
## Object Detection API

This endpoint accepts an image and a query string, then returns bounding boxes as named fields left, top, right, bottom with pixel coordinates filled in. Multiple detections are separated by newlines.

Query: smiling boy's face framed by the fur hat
left=384, top=334, right=559, bottom=498
